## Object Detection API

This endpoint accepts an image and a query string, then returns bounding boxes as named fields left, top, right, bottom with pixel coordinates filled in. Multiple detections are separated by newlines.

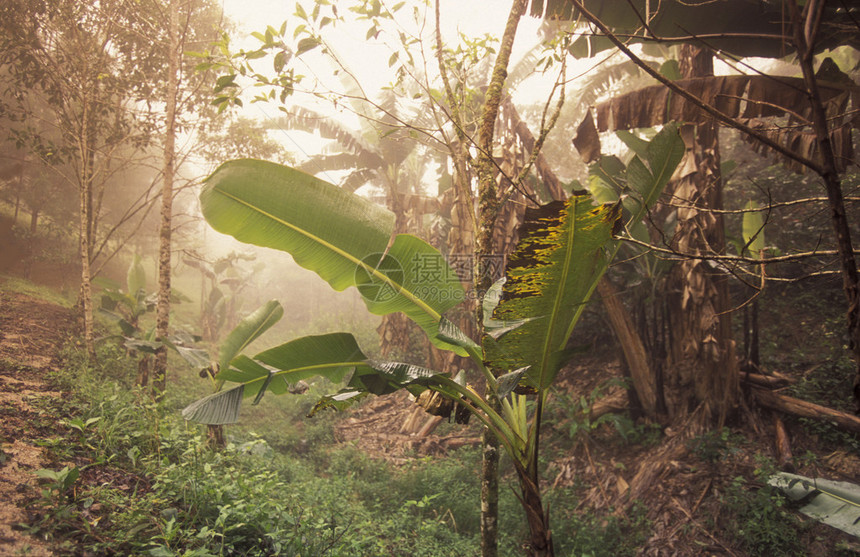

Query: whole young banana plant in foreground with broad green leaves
left=183, top=126, right=683, bottom=555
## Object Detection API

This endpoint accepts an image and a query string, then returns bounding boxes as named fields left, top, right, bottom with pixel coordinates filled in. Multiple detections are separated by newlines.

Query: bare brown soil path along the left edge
left=0, top=291, right=74, bottom=557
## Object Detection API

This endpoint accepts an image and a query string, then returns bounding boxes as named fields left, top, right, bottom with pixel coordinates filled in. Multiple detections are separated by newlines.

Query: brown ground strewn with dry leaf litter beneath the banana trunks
left=336, top=350, right=860, bottom=557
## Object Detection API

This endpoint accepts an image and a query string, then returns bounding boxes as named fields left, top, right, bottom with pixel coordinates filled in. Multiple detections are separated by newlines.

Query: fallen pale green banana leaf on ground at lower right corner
left=767, top=472, right=860, bottom=537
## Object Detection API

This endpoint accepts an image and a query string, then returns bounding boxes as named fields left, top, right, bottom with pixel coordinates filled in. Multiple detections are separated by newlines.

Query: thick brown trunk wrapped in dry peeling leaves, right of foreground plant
left=663, top=45, right=738, bottom=428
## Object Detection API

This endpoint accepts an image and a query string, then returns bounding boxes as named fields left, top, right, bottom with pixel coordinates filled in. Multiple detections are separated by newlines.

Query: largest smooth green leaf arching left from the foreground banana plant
left=200, top=159, right=465, bottom=355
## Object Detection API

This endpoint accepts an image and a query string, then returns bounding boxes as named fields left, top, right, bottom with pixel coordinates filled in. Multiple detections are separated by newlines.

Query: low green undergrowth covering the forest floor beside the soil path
left=23, top=336, right=644, bottom=557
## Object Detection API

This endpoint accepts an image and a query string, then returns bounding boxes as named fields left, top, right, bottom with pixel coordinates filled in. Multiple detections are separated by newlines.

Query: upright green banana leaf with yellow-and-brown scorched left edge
left=487, top=195, right=621, bottom=391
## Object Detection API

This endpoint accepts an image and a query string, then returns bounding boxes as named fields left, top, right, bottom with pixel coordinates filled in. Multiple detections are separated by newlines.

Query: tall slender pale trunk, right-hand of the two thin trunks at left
left=152, top=2, right=180, bottom=400
